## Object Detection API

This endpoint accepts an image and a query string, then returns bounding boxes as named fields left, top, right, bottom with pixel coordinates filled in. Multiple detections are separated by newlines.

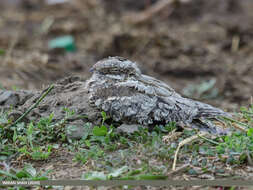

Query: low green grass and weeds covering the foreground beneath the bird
left=0, top=106, right=253, bottom=185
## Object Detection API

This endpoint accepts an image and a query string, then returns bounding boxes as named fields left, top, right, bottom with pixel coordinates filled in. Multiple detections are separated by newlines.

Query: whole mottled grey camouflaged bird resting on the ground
left=86, top=57, right=228, bottom=134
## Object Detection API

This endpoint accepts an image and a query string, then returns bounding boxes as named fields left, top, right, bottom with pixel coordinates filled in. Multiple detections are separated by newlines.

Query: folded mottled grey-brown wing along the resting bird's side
left=89, top=80, right=229, bottom=130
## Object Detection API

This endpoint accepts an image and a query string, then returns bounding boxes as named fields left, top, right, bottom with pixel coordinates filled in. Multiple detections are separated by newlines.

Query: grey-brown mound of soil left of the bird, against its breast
left=0, top=77, right=101, bottom=123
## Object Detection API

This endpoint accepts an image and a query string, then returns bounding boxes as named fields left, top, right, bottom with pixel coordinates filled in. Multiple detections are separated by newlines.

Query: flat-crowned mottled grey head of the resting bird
left=90, top=57, right=141, bottom=76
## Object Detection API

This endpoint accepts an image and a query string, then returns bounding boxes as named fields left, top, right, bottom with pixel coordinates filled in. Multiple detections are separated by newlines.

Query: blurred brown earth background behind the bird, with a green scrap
left=0, top=0, right=253, bottom=111
